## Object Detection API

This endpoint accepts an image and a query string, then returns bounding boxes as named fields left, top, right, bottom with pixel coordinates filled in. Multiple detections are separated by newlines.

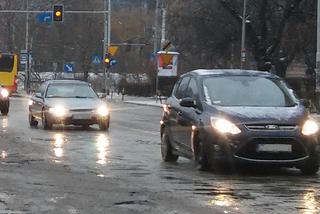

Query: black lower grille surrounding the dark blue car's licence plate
left=235, top=138, right=307, bottom=160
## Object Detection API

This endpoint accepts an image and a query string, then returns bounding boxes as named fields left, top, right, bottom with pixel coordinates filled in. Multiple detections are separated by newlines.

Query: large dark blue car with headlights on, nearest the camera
left=161, top=70, right=319, bottom=174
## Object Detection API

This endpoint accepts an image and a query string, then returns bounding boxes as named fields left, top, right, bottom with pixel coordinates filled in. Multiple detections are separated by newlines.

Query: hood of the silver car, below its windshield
left=45, top=98, right=106, bottom=109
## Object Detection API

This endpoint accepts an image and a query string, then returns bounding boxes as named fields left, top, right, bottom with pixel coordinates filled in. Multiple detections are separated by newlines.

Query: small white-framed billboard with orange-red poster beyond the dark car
left=157, top=51, right=179, bottom=77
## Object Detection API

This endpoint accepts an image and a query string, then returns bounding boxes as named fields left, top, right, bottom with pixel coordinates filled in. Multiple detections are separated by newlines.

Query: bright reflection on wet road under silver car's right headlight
left=96, top=134, right=110, bottom=165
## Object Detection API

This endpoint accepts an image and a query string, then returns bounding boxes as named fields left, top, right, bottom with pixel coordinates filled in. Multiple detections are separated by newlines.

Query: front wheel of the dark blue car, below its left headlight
left=194, top=140, right=210, bottom=171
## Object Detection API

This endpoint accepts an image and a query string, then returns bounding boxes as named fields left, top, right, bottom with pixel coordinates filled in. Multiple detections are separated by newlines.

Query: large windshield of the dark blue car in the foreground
left=203, top=76, right=297, bottom=107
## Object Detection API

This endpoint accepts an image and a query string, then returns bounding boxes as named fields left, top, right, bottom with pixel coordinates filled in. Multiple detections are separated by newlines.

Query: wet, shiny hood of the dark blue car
left=213, top=105, right=308, bottom=125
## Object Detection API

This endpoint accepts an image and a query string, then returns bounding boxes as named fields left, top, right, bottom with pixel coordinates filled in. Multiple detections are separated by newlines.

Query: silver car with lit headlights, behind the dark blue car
left=29, top=80, right=110, bottom=130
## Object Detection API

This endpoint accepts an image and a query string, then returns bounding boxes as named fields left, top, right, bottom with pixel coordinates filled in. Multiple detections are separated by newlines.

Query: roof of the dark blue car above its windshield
left=186, top=69, right=279, bottom=78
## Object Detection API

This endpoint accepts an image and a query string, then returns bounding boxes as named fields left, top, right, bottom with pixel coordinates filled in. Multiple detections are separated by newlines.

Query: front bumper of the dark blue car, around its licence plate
left=202, top=127, right=320, bottom=166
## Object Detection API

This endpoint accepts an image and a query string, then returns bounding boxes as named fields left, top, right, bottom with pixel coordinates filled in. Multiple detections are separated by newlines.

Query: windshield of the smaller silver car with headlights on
left=46, top=84, right=97, bottom=98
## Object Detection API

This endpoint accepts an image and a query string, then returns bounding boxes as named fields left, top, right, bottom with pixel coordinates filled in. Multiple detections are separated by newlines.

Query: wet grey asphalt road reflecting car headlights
left=0, top=98, right=320, bottom=214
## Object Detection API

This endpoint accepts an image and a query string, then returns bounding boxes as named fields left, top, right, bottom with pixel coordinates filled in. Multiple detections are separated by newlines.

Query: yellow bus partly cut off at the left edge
left=0, top=53, right=18, bottom=94
